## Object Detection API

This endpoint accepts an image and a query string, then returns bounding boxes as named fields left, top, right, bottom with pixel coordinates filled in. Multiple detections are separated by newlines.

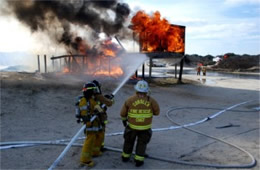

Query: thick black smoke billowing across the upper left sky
left=2, top=0, right=130, bottom=50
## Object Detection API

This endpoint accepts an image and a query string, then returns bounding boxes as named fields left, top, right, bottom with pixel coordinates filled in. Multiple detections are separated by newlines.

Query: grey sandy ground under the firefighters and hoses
left=0, top=73, right=260, bottom=169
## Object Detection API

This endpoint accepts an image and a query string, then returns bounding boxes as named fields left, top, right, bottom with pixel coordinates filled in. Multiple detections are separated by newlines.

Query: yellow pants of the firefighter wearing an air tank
left=80, top=131, right=103, bottom=163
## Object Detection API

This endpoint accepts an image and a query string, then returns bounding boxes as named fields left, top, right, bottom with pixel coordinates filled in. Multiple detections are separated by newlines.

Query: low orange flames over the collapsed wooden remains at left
left=63, top=39, right=124, bottom=77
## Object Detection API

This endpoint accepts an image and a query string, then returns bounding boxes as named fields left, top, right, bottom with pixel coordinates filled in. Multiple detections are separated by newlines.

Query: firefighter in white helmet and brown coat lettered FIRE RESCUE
left=120, top=80, right=160, bottom=167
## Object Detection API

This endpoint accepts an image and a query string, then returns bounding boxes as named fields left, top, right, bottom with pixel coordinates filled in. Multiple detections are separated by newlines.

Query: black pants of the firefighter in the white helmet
left=122, top=126, right=152, bottom=161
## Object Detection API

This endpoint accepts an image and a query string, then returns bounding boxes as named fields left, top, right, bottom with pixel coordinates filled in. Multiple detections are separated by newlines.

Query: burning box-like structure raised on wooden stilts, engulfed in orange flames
left=130, top=11, right=185, bottom=82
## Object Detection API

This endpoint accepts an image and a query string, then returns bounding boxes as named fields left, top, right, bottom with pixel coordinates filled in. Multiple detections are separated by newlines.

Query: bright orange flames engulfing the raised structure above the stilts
left=131, top=11, right=185, bottom=52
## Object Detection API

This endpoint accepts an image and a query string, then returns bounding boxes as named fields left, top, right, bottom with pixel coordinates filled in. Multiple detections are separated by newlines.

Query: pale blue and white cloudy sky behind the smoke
left=0, top=0, right=260, bottom=56
